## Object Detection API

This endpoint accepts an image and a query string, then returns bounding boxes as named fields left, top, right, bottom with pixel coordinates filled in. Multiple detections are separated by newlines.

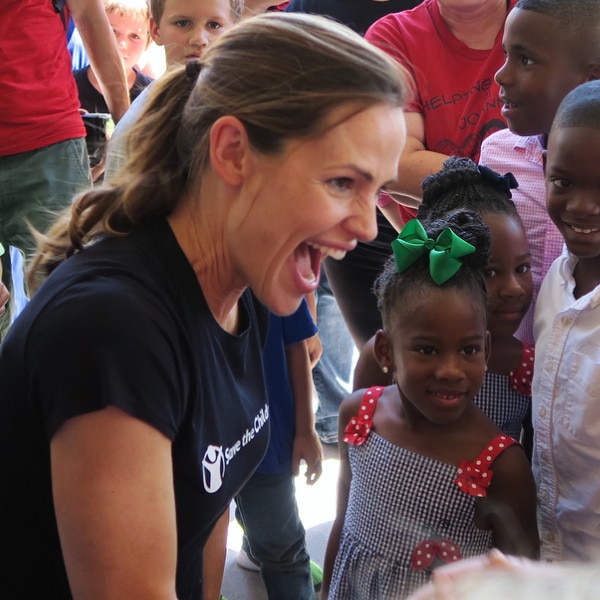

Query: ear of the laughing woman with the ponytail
left=210, top=115, right=251, bottom=186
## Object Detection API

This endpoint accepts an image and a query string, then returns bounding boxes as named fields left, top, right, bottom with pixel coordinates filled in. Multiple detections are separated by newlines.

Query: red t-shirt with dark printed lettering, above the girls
left=365, top=0, right=517, bottom=219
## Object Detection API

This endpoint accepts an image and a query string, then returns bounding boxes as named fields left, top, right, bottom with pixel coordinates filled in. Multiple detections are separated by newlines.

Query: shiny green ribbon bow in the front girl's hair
left=392, top=219, right=475, bottom=285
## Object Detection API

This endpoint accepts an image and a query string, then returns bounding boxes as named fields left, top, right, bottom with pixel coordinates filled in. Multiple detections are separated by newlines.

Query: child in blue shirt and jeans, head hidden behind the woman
left=235, top=300, right=323, bottom=600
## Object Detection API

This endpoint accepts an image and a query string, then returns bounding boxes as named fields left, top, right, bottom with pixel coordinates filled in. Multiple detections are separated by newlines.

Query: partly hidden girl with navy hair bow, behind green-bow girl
left=354, top=157, right=535, bottom=455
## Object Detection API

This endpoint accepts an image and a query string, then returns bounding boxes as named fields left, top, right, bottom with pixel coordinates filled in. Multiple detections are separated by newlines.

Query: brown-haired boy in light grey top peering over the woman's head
left=105, top=0, right=243, bottom=179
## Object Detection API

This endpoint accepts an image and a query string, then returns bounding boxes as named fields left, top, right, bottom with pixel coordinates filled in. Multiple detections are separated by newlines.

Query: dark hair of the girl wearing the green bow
left=374, top=210, right=490, bottom=327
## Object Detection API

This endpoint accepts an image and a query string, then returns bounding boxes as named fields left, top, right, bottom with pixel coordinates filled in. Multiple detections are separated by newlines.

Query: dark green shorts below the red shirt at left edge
left=0, top=138, right=92, bottom=340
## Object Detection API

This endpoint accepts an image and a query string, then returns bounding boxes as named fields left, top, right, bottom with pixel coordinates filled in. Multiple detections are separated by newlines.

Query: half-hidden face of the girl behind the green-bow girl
left=483, top=214, right=533, bottom=338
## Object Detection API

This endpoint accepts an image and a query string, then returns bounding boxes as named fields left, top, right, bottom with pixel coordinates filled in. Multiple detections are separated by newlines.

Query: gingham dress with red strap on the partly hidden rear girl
left=474, top=344, right=534, bottom=440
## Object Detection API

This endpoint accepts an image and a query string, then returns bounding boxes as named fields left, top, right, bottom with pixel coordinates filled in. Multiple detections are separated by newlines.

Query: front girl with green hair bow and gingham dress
left=324, top=211, right=539, bottom=600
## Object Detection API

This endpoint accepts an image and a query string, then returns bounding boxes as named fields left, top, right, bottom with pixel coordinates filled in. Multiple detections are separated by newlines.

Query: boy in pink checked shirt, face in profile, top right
left=479, top=0, right=600, bottom=344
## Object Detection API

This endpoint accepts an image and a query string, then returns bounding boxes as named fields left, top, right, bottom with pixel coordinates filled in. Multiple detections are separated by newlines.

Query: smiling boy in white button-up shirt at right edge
left=533, top=81, right=600, bottom=562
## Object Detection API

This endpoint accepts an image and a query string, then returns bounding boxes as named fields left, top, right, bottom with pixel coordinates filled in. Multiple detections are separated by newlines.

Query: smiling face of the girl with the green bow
left=387, top=287, right=489, bottom=425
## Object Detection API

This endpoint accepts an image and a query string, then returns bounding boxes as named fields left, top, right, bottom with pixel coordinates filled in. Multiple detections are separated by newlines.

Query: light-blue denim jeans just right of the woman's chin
left=313, top=270, right=355, bottom=444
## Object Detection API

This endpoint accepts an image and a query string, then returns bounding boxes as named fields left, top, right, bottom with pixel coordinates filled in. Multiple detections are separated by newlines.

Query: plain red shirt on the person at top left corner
left=0, top=0, right=85, bottom=156
